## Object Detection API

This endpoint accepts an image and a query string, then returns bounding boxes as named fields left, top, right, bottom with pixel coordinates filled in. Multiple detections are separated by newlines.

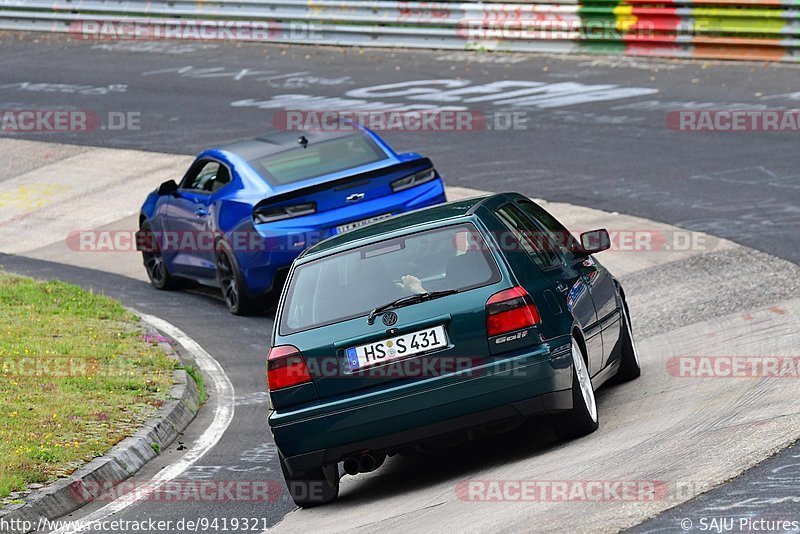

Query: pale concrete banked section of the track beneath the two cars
left=0, top=139, right=800, bottom=532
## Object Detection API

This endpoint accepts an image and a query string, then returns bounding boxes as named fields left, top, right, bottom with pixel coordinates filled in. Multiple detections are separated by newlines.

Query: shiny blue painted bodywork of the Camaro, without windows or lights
left=140, top=128, right=446, bottom=298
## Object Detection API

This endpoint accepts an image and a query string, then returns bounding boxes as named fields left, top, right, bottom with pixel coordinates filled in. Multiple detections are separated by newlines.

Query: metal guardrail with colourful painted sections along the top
left=0, top=0, right=800, bottom=62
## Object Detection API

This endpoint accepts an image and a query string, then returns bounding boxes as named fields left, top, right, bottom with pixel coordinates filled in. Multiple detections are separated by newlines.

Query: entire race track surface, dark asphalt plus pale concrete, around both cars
left=0, top=34, right=800, bottom=532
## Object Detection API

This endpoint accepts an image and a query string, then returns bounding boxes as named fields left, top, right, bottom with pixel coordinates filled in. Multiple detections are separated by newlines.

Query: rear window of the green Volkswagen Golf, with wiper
left=280, top=223, right=500, bottom=335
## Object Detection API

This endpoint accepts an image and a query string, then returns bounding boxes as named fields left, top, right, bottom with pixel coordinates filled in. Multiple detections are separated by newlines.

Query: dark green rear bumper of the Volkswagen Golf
left=269, top=344, right=572, bottom=471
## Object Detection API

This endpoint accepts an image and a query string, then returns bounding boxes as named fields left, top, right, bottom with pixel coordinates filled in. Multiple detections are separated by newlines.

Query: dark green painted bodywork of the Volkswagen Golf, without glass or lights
left=269, top=193, right=632, bottom=478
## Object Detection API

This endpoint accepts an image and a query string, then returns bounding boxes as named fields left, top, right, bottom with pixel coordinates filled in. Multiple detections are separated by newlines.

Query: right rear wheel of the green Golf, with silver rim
left=555, top=336, right=600, bottom=440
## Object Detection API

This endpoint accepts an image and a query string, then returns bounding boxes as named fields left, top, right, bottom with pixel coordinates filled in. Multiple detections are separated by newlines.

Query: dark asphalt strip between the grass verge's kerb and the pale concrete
left=0, top=256, right=294, bottom=525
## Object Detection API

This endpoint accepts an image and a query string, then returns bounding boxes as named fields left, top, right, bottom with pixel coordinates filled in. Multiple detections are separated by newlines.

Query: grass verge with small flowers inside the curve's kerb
left=0, top=272, right=175, bottom=506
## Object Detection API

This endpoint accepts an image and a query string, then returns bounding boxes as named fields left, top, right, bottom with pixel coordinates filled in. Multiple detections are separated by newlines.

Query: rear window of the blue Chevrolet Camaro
left=250, top=134, right=386, bottom=185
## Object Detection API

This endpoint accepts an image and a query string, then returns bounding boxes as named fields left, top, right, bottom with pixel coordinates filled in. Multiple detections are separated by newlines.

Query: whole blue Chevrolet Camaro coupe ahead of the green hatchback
left=137, top=127, right=446, bottom=314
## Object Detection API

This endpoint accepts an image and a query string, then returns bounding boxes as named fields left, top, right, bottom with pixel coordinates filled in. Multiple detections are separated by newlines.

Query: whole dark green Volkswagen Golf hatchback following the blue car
left=267, top=193, right=640, bottom=507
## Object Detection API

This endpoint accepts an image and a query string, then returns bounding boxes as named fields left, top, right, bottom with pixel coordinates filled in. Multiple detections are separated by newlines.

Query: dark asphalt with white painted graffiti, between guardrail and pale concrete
left=0, top=34, right=800, bottom=262
